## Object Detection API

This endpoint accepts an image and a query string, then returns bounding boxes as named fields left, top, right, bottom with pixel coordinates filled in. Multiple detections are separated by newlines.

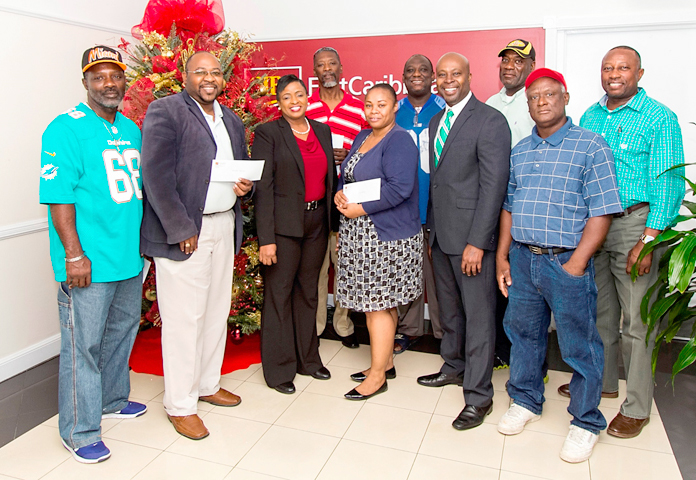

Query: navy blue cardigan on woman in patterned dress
left=338, top=125, right=421, bottom=242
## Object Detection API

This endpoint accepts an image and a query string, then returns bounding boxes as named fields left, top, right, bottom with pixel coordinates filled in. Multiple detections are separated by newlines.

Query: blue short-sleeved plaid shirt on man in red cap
left=503, top=117, right=623, bottom=248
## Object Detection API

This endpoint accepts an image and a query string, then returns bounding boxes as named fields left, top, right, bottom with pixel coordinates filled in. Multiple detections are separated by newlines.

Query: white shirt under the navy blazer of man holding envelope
left=192, top=97, right=237, bottom=215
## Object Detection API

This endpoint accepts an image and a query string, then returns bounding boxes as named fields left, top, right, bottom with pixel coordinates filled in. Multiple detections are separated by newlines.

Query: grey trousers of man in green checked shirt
left=595, top=207, right=662, bottom=419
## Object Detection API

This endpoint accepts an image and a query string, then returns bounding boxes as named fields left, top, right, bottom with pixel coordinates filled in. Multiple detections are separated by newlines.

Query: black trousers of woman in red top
left=261, top=204, right=329, bottom=387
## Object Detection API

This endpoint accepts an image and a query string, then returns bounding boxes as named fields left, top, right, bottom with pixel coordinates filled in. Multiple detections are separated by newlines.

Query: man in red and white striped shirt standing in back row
left=306, top=47, right=368, bottom=348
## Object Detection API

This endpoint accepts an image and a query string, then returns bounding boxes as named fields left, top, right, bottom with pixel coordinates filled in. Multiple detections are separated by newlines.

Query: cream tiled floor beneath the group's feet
left=0, top=340, right=682, bottom=480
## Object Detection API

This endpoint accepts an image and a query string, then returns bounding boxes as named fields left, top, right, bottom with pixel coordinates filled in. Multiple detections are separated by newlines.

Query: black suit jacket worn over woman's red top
left=252, top=117, right=337, bottom=246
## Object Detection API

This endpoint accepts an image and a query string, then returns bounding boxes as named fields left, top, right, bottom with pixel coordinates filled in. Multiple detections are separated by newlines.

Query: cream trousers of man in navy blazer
left=154, top=210, right=234, bottom=416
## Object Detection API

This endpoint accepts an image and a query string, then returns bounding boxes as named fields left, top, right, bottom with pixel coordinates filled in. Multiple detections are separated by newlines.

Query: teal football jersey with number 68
left=39, top=103, right=143, bottom=282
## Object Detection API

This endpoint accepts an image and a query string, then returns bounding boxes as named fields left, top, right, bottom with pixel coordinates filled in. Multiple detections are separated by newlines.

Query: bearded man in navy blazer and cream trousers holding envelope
left=140, top=52, right=253, bottom=440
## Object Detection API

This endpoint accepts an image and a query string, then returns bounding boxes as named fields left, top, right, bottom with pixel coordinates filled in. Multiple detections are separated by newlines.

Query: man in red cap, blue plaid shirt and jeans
left=496, top=68, right=622, bottom=463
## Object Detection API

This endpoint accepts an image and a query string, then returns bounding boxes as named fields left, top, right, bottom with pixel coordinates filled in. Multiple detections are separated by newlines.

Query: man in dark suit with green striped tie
left=418, top=53, right=510, bottom=430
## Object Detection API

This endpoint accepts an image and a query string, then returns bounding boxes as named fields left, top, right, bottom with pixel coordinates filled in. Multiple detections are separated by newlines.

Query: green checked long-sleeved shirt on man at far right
left=580, top=88, right=685, bottom=230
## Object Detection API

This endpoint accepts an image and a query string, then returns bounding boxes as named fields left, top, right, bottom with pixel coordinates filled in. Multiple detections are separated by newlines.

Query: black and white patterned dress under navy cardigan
left=336, top=152, right=423, bottom=312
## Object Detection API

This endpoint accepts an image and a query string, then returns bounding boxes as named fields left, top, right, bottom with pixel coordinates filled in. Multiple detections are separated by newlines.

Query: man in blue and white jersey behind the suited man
left=394, top=54, right=445, bottom=353
